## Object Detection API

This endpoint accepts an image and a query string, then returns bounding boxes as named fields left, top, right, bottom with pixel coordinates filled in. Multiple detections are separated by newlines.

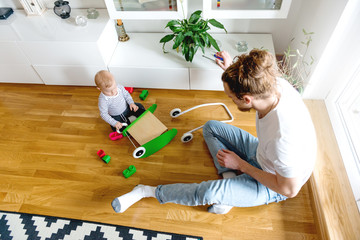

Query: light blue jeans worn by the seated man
left=156, top=120, right=286, bottom=207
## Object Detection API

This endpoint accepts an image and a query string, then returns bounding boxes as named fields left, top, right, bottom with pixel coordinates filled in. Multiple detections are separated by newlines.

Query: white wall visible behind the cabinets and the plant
left=0, top=0, right=302, bottom=54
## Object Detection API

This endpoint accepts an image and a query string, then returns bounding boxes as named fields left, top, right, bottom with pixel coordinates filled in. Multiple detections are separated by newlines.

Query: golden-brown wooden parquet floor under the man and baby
left=0, top=84, right=318, bottom=240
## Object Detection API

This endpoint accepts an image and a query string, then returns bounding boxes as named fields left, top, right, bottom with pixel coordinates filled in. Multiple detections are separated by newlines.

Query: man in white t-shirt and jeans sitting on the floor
left=112, top=49, right=317, bottom=214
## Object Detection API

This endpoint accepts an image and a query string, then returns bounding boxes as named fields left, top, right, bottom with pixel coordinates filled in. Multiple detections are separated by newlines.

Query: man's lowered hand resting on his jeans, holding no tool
left=216, top=149, right=247, bottom=172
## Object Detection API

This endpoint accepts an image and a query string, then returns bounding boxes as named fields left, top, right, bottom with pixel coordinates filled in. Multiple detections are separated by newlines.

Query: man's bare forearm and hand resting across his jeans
left=216, top=149, right=301, bottom=198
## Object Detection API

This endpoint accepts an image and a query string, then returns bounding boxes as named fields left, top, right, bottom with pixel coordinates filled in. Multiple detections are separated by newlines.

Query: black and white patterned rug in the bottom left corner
left=0, top=211, right=203, bottom=240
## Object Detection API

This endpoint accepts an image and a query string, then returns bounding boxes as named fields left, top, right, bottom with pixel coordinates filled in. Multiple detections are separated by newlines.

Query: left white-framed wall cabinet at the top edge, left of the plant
left=105, top=0, right=187, bottom=19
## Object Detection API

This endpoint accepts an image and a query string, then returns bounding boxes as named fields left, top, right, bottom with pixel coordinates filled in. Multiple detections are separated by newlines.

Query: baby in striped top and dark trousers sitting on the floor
left=95, top=70, right=145, bottom=131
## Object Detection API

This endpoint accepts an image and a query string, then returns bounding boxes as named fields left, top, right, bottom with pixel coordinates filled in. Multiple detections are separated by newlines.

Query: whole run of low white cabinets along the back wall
left=0, top=9, right=274, bottom=90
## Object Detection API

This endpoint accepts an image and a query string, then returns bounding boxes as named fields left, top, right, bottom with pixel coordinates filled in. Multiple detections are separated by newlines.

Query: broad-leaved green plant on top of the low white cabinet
left=160, top=10, right=227, bottom=62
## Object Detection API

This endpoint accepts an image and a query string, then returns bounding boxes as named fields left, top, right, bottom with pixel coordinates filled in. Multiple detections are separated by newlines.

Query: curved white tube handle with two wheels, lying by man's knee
left=170, top=103, right=234, bottom=143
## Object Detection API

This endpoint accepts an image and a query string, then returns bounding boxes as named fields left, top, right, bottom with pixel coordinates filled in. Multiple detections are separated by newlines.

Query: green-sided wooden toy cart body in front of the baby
left=119, top=104, right=177, bottom=158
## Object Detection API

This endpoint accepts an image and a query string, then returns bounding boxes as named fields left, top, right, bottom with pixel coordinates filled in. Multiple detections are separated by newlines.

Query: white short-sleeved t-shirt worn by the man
left=256, top=78, right=317, bottom=185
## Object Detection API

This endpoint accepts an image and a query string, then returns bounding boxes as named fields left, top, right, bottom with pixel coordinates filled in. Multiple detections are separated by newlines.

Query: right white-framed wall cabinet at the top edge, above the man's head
left=203, top=0, right=292, bottom=19
